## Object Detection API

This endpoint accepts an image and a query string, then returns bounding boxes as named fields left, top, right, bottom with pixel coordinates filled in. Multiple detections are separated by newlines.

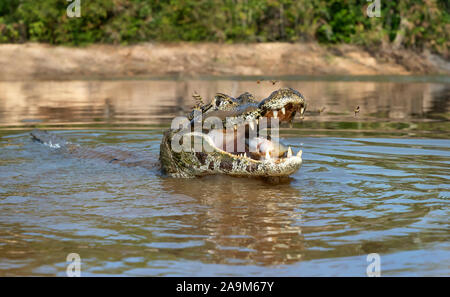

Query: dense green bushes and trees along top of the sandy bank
left=0, top=0, right=450, bottom=56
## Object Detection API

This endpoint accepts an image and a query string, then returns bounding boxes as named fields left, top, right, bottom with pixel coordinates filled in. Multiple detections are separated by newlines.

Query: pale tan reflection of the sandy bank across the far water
left=0, top=79, right=450, bottom=132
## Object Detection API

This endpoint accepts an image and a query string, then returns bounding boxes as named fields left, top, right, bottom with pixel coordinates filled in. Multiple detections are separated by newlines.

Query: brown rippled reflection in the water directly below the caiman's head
left=163, top=177, right=304, bottom=265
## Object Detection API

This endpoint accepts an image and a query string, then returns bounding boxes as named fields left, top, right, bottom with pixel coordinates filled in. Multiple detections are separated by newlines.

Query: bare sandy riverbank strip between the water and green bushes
left=0, top=43, right=450, bottom=80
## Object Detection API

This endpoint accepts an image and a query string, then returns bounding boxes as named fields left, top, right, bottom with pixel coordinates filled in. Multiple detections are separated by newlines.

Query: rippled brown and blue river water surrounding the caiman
left=0, top=77, right=450, bottom=276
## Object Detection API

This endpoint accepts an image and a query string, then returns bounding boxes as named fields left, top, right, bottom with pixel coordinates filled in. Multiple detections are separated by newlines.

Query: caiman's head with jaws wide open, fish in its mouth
left=160, top=88, right=306, bottom=178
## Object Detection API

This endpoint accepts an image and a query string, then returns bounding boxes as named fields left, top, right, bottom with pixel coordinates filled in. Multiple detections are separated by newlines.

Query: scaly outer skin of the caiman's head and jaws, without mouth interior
left=160, top=88, right=306, bottom=178
